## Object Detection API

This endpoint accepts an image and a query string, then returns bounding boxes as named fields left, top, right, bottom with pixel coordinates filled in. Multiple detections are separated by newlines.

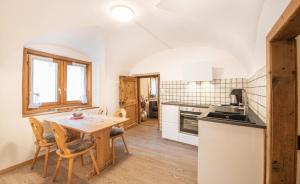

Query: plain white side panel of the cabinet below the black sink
left=198, top=120, right=264, bottom=184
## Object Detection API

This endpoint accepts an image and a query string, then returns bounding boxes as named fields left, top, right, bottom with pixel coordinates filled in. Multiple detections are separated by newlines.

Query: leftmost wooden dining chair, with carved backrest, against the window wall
left=29, top=117, right=55, bottom=177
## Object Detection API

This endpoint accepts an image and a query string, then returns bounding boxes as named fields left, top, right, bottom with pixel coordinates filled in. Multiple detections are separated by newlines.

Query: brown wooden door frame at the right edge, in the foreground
left=265, top=0, right=300, bottom=184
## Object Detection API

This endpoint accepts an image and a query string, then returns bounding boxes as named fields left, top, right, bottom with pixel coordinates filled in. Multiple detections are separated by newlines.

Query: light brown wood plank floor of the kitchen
left=0, top=125, right=197, bottom=184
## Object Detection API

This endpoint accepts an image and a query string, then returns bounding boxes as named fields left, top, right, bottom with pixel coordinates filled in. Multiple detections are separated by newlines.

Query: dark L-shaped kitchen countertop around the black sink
left=162, top=101, right=266, bottom=129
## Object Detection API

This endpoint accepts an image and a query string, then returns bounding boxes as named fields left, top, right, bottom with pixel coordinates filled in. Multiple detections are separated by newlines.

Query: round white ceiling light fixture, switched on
left=111, top=5, right=134, bottom=22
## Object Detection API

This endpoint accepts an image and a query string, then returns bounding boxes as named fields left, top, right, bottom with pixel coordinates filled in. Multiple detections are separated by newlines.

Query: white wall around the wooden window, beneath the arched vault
left=0, top=44, right=104, bottom=170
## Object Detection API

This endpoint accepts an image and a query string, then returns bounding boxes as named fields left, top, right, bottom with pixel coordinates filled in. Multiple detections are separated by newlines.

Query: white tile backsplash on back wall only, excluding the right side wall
left=160, top=78, right=248, bottom=105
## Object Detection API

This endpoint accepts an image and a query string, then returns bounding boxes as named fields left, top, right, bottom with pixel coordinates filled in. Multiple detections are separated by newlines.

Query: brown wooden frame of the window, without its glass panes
left=22, top=48, right=92, bottom=116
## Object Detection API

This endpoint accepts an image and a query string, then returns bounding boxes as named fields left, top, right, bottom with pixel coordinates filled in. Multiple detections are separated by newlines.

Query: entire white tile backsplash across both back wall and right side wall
left=160, top=67, right=267, bottom=131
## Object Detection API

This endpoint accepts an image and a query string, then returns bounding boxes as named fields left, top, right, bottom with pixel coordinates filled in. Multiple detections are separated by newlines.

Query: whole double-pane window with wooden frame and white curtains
left=23, top=49, right=92, bottom=115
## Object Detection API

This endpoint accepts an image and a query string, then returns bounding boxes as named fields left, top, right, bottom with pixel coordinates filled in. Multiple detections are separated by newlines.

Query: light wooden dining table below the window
left=45, top=115, right=129, bottom=174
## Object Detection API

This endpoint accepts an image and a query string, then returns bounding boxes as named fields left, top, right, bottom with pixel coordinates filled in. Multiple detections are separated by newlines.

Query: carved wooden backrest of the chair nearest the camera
left=50, top=122, right=70, bottom=154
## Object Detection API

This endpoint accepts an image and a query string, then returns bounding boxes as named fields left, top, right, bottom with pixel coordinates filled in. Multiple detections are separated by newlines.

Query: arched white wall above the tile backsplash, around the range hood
left=130, top=47, right=247, bottom=81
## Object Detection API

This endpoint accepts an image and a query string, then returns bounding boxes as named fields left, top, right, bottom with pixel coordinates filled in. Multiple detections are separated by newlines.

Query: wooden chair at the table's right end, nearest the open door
left=110, top=110, right=129, bottom=164
